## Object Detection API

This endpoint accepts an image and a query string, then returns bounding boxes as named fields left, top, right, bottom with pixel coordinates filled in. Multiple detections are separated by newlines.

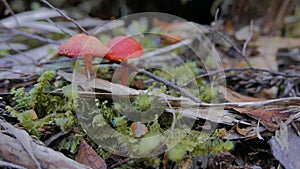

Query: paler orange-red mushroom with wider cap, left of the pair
left=59, top=34, right=109, bottom=76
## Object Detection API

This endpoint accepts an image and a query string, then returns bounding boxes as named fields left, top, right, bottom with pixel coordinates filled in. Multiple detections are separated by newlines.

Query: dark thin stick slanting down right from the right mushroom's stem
left=121, top=62, right=201, bottom=103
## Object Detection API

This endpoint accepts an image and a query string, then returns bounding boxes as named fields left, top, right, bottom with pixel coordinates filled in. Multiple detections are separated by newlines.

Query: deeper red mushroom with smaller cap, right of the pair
left=105, top=36, right=144, bottom=85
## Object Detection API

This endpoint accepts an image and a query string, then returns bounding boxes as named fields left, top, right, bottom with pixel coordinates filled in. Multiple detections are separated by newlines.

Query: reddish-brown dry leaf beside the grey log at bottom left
left=76, top=138, right=107, bottom=169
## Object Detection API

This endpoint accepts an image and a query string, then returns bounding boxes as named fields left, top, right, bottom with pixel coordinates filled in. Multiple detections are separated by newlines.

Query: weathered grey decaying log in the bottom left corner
left=0, top=120, right=88, bottom=169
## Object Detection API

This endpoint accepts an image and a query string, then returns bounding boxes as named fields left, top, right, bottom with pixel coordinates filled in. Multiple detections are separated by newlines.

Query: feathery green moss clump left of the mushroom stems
left=6, top=71, right=75, bottom=137
